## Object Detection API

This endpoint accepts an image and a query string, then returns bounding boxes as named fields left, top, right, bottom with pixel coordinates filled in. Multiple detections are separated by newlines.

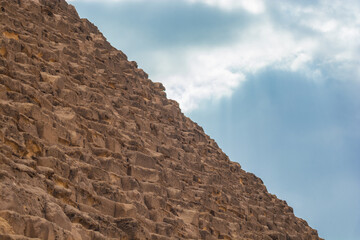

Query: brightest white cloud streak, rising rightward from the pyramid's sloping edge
left=154, top=25, right=316, bottom=112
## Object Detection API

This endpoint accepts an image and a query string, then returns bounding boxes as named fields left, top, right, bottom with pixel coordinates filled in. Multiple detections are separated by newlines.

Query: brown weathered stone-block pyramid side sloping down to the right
left=0, top=0, right=319, bottom=240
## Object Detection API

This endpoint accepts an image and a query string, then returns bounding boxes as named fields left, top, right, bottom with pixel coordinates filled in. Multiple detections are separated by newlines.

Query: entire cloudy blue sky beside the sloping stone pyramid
left=69, top=0, right=360, bottom=240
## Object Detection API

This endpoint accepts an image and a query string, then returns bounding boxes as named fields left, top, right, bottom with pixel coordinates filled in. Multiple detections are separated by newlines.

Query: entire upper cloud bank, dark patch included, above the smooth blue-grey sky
left=69, top=0, right=360, bottom=112
